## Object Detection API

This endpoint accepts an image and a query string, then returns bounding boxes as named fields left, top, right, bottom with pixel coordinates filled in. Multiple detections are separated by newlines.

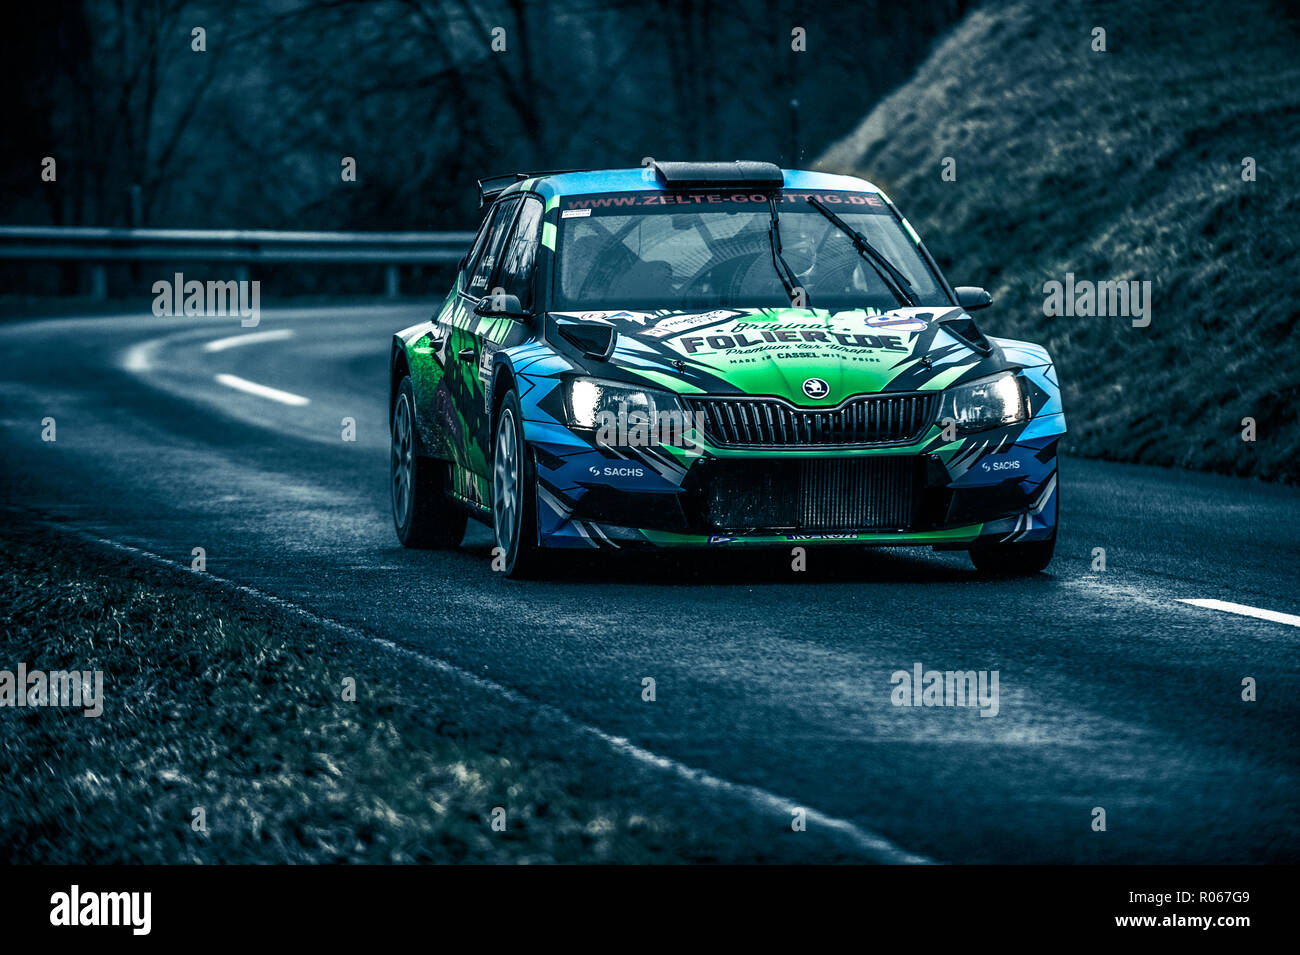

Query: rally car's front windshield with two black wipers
left=554, top=190, right=950, bottom=311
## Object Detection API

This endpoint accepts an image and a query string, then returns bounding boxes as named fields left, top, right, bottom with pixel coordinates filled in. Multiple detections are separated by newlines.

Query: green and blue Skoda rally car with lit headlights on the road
left=390, top=161, right=1065, bottom=576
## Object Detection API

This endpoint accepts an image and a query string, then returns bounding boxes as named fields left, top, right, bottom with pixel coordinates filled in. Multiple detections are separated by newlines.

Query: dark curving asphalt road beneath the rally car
left=0, top=305, right=1300, bottom=863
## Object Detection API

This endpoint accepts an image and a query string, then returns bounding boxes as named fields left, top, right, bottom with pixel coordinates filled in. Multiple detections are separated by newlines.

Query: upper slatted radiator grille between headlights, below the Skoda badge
left=686, top=392, right=936, bottom=448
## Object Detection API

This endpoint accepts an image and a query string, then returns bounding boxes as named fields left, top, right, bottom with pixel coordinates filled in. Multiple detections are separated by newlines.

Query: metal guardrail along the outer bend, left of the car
left=0, top=226, right=475, bottom=299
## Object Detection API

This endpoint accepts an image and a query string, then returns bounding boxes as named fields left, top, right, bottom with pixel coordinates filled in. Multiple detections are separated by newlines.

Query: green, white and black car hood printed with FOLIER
left=551, top=307, right=1009, bottom=407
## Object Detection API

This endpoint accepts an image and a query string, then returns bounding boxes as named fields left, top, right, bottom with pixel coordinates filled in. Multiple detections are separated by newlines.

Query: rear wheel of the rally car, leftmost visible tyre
left=389, top=376, right=467, bottom=551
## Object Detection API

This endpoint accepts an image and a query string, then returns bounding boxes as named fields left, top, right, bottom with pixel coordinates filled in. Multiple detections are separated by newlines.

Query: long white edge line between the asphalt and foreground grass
left=55, top=524, right=935, bottom=865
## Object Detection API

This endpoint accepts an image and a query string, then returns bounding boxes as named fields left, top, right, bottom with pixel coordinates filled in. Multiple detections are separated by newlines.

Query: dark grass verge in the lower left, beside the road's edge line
left=0, top=518, right=842, bottom=864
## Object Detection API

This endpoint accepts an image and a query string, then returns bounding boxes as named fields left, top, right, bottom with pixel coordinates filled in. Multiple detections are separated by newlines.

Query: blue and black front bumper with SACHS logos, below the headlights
left=534, top=421, right=1060, bottom=548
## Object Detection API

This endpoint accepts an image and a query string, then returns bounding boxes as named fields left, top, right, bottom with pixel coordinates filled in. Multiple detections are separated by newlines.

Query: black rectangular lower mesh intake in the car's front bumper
left=703, top=455, right=920, bottom=533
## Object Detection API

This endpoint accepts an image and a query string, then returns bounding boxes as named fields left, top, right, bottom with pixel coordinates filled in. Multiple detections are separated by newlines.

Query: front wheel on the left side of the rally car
left=491, top=388, right=541, bottom=577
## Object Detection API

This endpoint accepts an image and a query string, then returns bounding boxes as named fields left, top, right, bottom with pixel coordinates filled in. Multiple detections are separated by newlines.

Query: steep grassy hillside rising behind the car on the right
left=818, top=0, right=1300, bottom=482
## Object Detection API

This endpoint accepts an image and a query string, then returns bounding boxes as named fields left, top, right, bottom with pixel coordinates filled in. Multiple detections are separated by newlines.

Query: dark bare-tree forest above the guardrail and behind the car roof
left=0, top=0, right=969, bottom=230
